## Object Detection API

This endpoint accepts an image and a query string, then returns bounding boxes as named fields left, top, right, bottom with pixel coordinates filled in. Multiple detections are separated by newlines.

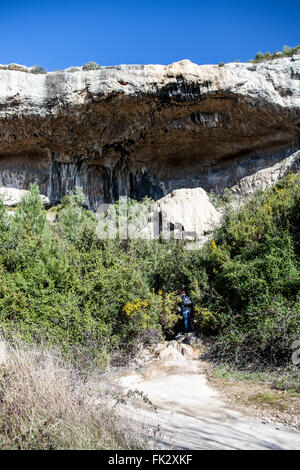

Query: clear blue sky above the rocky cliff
left=0, top=0, right=300, bottom=70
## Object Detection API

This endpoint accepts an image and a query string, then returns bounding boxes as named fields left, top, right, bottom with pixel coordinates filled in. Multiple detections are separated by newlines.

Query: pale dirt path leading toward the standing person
left=120, top=357, right=300, bottom=450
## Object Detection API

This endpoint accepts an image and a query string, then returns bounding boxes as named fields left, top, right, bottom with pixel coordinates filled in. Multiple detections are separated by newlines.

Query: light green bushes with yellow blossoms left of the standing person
left=0, top=185, right=183, bottom=355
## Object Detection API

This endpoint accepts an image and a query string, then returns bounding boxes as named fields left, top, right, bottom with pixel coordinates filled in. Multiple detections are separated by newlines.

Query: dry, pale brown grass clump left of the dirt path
left=0, top=343, right=146, bottom=449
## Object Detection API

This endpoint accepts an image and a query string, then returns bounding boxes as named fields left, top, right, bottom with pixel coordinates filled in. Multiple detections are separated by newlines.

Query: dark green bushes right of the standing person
left=193, top=175, right=300, bottom=363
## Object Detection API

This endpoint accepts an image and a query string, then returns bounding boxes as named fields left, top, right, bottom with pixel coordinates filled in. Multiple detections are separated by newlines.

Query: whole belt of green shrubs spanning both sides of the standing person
left=0, top=175, right=300, bottom=367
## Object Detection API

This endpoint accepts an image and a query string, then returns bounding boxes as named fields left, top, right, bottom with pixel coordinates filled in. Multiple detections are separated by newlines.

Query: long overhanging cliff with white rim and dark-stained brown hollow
left=0, top=55, right=300, bottom=209
